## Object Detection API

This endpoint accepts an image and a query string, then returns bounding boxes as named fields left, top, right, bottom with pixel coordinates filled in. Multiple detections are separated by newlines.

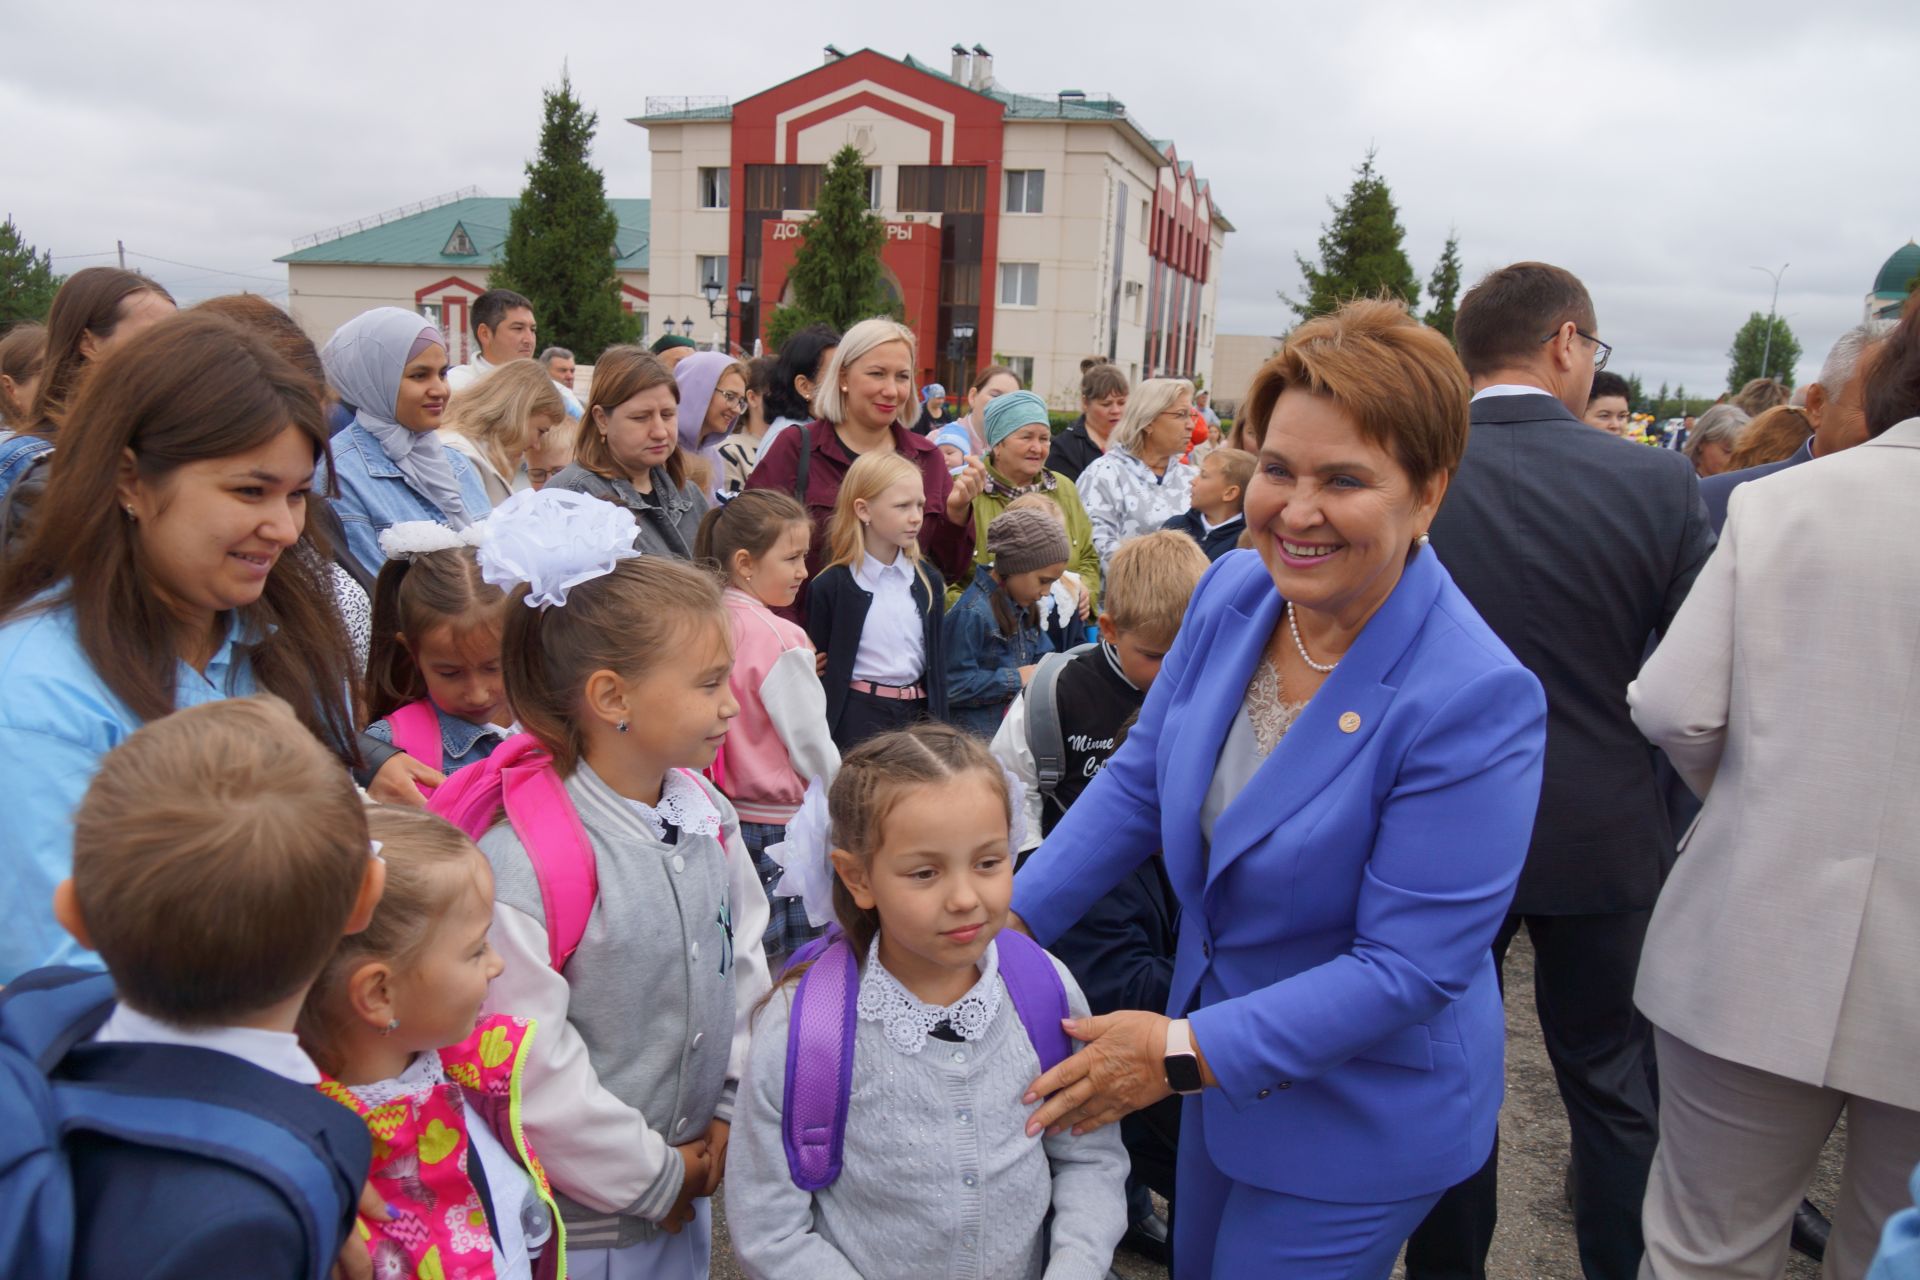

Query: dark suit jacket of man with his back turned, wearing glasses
left=1432, top=391, right=1715, bottom=915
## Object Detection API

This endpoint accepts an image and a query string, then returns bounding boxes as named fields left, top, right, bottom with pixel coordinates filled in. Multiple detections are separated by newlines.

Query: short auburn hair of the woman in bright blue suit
left=1246, top=299, right=1473, bottom=489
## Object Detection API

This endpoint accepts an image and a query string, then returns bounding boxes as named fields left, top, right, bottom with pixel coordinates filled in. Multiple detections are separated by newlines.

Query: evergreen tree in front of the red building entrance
left=766, top=146, right=897, bottom=349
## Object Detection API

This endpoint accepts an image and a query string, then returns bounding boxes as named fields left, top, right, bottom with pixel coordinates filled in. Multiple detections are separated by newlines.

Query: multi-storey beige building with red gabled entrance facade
left=632, top=46, right=1233, bottom=407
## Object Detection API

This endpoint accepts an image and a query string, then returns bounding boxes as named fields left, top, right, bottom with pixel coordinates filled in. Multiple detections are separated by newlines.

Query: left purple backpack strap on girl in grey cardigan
left=780, top=931, right=860, bottom=1192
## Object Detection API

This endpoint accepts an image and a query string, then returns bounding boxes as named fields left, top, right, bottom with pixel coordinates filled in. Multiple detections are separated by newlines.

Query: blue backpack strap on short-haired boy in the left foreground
left=54, top=1082, right=348, bottom=1280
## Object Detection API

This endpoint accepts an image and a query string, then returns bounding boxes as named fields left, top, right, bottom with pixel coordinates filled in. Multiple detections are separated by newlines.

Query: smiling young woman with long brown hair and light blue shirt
left=0, top=315, right=357, bottom=983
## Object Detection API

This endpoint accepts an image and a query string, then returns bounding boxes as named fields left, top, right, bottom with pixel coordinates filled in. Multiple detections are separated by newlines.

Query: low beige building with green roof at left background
left=276, top=192, right=649, bottom=365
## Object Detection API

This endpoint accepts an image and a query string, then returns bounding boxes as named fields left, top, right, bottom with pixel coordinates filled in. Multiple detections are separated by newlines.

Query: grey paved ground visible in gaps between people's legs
left=714, top=933, right=1845, bottom=1280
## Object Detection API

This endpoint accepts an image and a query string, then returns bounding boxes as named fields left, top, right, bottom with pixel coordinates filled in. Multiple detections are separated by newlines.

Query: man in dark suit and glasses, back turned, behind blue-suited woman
left=1407, top=263, right=1713, bottom=1280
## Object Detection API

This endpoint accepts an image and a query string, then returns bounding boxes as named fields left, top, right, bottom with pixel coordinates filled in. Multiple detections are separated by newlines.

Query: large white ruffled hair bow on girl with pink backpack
left=480, top=486, right=639, bottom=608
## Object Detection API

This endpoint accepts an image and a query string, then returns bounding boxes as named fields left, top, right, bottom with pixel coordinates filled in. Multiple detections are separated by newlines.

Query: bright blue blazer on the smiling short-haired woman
left=1014, top=551, right=1546, bottom=1203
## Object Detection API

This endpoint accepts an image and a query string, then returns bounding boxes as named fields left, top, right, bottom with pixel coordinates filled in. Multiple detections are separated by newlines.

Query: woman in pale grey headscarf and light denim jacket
left=321, top=307, right=493, bottom=574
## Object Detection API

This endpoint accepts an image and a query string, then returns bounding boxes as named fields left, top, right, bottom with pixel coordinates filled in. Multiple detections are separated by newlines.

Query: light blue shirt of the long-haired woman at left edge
left=0, top=604, right=257, bottom=983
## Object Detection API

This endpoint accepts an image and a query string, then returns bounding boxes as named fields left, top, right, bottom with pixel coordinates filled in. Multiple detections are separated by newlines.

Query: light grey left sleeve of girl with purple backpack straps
left=720, top=988, right=860, bottom=1280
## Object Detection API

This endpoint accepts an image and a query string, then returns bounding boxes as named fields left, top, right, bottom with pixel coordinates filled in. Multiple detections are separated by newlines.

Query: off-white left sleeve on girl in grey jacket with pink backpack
left=486, top=902, right=683, bottom=1221
